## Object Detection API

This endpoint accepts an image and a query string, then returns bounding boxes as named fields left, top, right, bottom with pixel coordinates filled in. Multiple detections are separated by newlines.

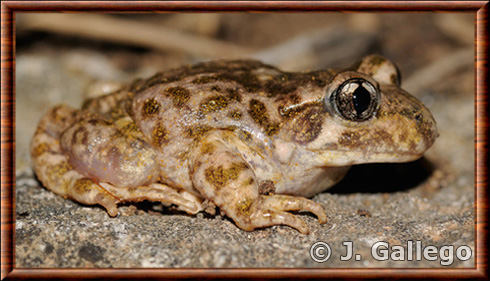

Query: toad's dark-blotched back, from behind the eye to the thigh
left=127, top=58, right=332, bottom=148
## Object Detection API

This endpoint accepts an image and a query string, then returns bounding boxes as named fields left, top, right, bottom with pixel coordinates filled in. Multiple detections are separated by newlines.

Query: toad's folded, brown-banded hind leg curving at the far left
left=31, top=105, right=119, bottom=216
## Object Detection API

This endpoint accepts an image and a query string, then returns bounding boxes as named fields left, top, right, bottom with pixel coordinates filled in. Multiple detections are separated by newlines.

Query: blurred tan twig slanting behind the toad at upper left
left=17, top=13, right=251, bottom=58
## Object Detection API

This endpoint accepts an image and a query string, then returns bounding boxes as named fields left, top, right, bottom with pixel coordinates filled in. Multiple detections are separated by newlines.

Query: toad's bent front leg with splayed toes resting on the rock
left=190, top=131, right=327, bottom=234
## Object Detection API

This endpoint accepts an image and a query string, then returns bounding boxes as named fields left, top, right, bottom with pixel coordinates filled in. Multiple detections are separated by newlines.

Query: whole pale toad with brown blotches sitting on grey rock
left=31, top=54, right=438, bottom=234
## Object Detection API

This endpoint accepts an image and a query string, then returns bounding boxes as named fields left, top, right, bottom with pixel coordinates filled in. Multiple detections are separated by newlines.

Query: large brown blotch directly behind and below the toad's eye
left=292, top=106, right=324, bottom=144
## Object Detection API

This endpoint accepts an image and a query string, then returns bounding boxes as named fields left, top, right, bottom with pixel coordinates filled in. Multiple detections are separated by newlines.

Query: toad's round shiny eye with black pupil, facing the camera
left=329, top=78, right=379, bottom=121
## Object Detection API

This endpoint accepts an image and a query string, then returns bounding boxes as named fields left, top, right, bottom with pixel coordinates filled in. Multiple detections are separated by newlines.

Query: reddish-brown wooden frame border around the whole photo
left=1, top=1, right=489, bottom=279
